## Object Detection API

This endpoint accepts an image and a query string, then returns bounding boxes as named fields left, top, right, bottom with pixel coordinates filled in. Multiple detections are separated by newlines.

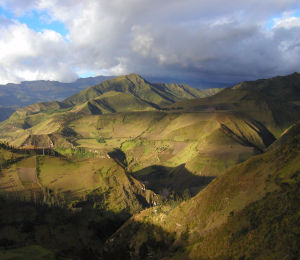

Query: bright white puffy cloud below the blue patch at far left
left=0, top=22, right=76, bottom=84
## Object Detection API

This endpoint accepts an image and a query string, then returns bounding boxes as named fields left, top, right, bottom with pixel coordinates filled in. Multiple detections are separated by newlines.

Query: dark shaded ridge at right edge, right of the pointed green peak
left=169, top=73, right=300, bottom=137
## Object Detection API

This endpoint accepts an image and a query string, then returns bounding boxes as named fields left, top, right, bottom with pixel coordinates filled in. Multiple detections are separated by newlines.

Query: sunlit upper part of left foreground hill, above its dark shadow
left=0, top=150, right=157, bottom=213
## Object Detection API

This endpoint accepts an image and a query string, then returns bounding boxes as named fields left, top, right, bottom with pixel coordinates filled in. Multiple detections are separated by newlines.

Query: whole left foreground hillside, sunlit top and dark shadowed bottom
left=0, top=145, right=158, bottom=259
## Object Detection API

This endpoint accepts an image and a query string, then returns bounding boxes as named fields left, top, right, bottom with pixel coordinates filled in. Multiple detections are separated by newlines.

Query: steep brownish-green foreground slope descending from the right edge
left=107, top=123, right=300, bottom=259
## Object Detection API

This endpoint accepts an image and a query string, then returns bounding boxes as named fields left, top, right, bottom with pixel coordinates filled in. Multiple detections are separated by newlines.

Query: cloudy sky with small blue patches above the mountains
left=0, top=0, right=300, bottom=87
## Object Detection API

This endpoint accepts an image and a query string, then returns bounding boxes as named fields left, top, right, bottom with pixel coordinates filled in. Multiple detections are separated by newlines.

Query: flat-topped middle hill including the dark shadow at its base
left=68, top=112, right=274, bottom=194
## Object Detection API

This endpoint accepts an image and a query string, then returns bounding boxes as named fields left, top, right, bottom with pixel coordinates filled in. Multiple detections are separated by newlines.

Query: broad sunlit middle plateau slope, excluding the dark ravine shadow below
left=2, top=108, right=275, bottom=184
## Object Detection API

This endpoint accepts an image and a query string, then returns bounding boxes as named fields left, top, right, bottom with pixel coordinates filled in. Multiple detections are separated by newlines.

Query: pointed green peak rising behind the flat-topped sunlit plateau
left=64, top=74, right=218, bottom=114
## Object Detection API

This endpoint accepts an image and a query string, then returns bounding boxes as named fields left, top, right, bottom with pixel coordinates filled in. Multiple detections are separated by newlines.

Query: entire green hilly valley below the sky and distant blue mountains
left=0, top=73, right=300, bottom=259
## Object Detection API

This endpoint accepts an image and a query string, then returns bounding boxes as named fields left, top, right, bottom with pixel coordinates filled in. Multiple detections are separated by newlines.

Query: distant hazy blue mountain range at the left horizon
left=0, top=76, right=112, bottom=121
